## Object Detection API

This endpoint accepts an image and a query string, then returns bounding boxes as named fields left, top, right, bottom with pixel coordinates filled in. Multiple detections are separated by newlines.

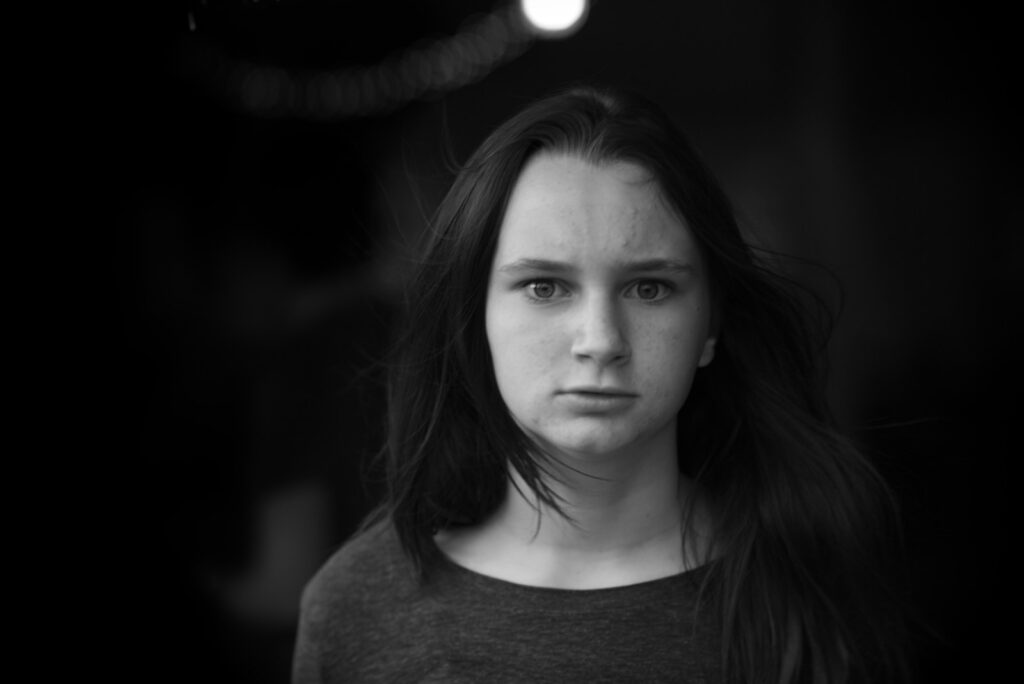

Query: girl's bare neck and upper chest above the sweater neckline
left=438, top=432, right=712, bottom=589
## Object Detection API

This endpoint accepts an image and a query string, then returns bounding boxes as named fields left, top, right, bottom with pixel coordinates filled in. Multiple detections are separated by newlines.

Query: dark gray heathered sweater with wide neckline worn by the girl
left=292, top=525, right=720, bottom=684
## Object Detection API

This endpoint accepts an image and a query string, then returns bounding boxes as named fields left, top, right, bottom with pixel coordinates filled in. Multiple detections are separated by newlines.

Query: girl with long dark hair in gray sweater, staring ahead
left=294, top=82, right=903, bottom=684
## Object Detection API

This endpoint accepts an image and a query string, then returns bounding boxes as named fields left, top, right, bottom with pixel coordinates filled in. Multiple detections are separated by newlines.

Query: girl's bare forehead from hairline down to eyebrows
left=496, top=153, right=699, bottom=261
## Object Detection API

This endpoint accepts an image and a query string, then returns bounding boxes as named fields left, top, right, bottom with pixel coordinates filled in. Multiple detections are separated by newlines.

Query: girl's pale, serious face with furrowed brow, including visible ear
left=486, top=154, right=715, bottom=457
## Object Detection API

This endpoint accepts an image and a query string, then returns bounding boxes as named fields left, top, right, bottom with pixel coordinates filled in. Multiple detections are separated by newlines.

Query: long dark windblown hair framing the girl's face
left=374, top=86, right=903, bottom=682
